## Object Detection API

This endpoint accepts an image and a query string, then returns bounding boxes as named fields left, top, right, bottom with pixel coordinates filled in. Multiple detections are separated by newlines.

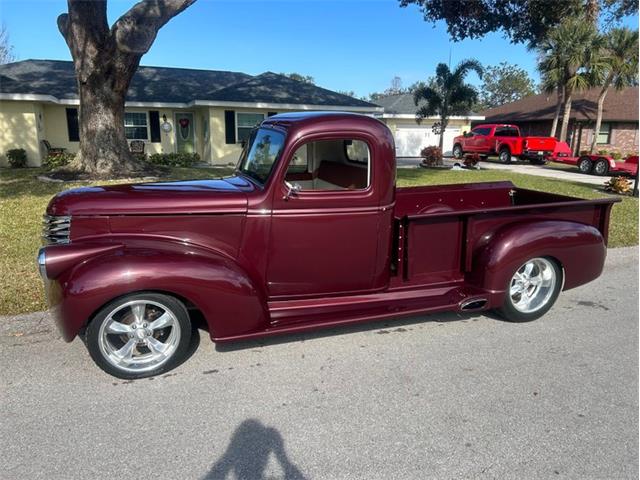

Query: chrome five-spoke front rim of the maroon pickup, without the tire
left=98, top=299, right=182, bottom=373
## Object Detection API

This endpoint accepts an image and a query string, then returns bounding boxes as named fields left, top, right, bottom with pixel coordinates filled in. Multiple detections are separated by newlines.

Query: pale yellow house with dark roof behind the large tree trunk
left=0, top=60, right=383, bottom=166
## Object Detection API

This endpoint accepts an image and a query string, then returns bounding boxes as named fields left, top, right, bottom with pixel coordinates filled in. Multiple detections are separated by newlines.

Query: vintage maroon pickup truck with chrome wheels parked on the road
left=38, top=112, right=615, bottom=378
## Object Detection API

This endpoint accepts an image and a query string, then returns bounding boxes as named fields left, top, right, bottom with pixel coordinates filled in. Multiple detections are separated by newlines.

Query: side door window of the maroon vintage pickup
left=285, top=139, right=371, bottom=191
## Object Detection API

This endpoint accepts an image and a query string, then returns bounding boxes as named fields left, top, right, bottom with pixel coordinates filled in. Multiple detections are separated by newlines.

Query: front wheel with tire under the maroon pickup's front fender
left=85, top=292, right=191, bottom=379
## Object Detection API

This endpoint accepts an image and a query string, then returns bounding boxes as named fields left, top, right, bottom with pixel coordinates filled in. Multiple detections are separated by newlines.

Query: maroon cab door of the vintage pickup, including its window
left=266, top=137, right=381, bottom=299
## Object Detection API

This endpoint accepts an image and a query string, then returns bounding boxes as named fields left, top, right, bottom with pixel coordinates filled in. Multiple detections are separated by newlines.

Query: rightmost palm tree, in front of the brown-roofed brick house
left=591, top=28, right=638, bottom=153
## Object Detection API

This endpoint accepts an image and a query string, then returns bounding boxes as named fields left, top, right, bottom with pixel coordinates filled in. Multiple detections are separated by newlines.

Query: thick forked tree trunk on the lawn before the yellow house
left=58, top=0, right=195, bottom=177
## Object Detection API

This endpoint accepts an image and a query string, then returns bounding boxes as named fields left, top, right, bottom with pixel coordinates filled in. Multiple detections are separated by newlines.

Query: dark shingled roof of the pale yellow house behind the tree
left=0, top=60, right=379, bottom=111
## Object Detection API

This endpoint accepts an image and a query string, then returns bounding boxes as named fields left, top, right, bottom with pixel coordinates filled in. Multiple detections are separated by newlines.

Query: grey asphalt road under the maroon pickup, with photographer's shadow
left=0, top=248, right=638, bottom=479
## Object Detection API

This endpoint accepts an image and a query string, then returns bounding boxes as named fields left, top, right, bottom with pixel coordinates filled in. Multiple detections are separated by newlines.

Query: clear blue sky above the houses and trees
left=0, top=0, right=638, bottom=95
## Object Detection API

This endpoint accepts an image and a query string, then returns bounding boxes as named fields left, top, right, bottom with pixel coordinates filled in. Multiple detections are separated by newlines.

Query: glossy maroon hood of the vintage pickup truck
left=47, top=176, right=255, bottom=215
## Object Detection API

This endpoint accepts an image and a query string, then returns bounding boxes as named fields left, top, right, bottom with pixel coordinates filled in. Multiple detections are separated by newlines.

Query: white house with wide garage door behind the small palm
left=376, top=93, right=484, bottom=158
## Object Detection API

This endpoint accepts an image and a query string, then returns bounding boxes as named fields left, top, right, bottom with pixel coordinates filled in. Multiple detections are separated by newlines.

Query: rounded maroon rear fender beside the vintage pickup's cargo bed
left=466, top=221, right=607, bottom=306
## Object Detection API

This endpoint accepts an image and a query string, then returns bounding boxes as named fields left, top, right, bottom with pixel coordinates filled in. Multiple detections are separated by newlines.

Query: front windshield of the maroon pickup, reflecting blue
left=238, top=128, right=284, bottom=184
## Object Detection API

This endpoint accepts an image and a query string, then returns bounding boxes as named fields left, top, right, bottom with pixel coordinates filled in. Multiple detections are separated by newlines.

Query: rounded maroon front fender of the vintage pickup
left=48, top=245, right=269, bottom=341
